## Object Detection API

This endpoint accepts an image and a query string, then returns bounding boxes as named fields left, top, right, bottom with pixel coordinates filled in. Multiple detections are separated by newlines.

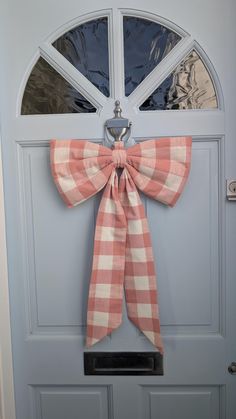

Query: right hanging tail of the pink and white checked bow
left=119, top=169, right=163, bottom=353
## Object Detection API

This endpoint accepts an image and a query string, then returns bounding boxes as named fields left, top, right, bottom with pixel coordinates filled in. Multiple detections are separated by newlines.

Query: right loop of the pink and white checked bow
left=127, top=137, right=192, bottom=206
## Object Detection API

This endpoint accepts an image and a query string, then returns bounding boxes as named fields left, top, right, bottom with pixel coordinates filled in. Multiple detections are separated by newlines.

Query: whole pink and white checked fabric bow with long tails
left=51, top=137, right=192, bottom=353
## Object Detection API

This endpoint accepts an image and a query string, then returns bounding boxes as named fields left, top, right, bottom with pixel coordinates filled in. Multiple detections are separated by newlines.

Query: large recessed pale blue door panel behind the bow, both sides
left=19, top=139, right=220, bottom=338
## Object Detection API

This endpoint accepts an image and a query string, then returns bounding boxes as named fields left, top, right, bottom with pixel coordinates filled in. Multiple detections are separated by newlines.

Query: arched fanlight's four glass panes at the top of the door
left=21, top=15, right=218, bottom=115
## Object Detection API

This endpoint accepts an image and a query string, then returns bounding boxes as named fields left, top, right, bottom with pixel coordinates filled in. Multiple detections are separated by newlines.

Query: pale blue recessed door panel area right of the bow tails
left=150, top=139, right=220, bottom=338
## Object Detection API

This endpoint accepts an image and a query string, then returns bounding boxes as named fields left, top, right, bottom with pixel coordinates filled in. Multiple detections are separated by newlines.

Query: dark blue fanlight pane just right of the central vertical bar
left=124, top=16, right=181, bottom=96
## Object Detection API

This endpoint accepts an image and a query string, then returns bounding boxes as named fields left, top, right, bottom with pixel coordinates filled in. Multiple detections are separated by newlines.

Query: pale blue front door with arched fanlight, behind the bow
left=0, top=0, right=236, bottom=419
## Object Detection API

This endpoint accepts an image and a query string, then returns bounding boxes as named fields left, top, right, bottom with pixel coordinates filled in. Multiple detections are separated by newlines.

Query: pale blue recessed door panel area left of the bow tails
left=20, top=145, right=95, bottom=334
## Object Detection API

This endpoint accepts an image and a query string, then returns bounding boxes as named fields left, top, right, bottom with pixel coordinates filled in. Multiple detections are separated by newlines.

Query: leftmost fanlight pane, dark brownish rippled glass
left=21, top=57, right=96, bottom=115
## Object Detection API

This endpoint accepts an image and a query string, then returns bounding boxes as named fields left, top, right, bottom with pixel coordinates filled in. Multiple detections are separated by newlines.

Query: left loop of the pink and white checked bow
left=50, top=140, right=113, bottom=208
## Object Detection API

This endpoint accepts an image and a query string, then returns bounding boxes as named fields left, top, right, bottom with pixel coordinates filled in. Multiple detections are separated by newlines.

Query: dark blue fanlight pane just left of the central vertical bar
left=53, top=17, right=110, bottom=96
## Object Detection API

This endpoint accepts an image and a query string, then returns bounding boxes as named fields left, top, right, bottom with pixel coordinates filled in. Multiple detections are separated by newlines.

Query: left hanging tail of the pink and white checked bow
left=86, top=170, right=127, bottom=347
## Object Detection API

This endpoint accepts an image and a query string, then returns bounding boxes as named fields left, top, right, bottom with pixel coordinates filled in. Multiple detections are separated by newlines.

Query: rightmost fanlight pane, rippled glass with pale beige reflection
left=139, top=51, right=218, bottom=111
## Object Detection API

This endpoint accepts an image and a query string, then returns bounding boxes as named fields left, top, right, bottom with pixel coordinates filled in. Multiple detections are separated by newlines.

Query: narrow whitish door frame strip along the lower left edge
left=0, top=138, right=16, bottom=419
